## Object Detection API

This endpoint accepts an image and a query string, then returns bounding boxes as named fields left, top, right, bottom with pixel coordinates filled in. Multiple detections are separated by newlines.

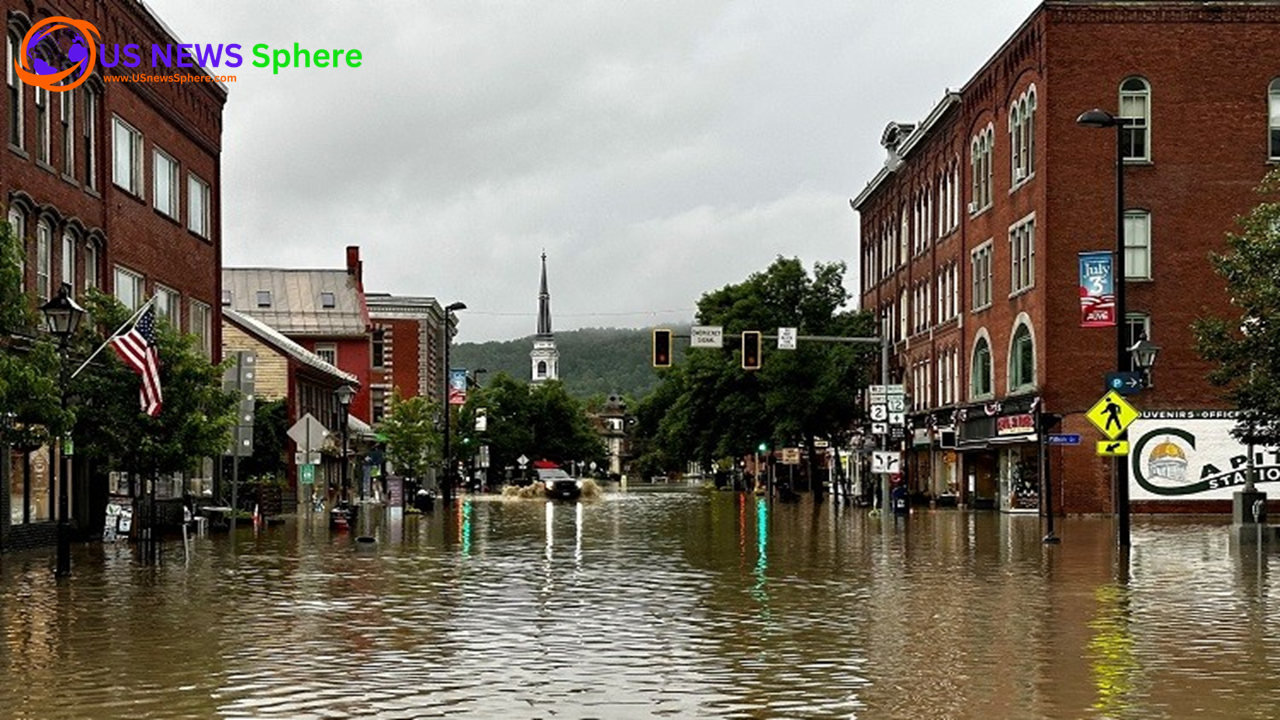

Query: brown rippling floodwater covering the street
left=0, top=492, right=1280, bottom=719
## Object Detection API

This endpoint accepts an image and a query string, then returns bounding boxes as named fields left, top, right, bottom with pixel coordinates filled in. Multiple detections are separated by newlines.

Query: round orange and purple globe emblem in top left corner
left=13, top=17, right=101, bottom=92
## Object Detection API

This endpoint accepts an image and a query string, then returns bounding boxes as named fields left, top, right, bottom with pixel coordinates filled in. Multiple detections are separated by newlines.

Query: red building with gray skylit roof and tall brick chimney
left=221, top=246, right=372, bottom=423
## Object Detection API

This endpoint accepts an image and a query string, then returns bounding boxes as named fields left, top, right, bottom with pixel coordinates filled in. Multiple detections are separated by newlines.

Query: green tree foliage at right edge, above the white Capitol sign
left=1193, top=170, right=1280, bottom=446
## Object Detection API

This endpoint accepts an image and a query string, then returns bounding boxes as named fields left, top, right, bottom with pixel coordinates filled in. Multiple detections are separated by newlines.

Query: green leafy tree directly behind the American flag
left=70, top=291, right=237, bottom=478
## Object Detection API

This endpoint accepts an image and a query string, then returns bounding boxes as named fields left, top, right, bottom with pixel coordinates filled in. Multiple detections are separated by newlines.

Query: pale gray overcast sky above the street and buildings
left=147, top=0, right=1038, bottom=342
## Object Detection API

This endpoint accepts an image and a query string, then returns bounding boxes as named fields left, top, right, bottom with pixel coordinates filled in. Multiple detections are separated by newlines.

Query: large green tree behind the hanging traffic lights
left=636, top=258, right=878, bottom=484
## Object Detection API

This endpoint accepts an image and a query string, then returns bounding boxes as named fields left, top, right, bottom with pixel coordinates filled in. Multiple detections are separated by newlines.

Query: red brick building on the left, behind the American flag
left=0, top=0, right=227, bottom=548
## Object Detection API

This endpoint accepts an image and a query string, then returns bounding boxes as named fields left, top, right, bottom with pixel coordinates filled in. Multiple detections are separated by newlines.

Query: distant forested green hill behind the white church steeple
left=449, top=328, right=687, bottom=398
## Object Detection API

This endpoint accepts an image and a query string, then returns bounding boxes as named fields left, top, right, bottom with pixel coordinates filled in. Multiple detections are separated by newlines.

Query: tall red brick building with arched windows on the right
left=851, top=0, right=1280, bottom=512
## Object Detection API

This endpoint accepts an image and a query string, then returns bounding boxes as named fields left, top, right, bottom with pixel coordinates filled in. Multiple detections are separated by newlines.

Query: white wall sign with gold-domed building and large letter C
left=1129, top=410, right=1280, bottom=501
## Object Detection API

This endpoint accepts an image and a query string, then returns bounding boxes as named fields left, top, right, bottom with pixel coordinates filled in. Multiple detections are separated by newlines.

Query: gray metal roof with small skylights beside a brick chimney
left=223, top=268, right=369, bottom=337
